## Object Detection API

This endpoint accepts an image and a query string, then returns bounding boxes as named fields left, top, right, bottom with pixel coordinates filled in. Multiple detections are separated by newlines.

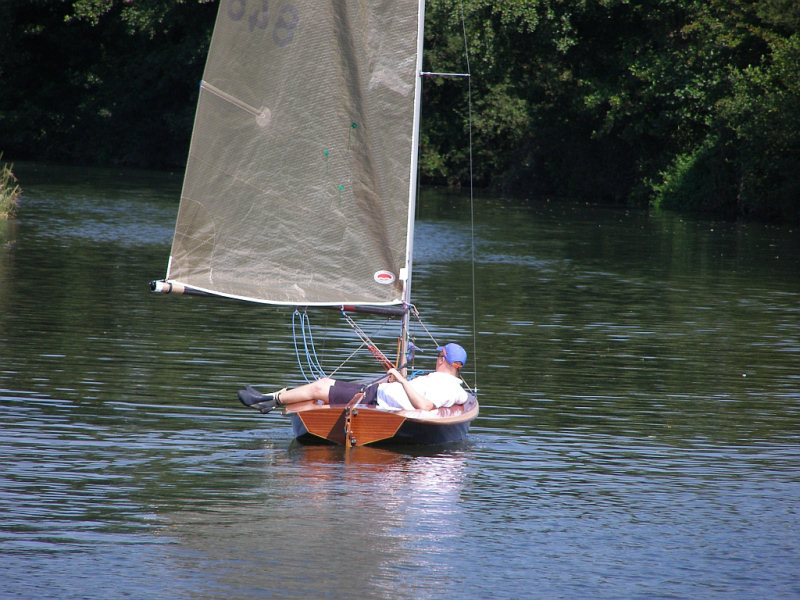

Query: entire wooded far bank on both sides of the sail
left=0, top=0, right=800, bottom=225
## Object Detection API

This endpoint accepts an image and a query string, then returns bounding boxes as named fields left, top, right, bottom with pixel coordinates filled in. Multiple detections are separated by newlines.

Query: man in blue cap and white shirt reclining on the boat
left=239, top=343, right=469, bottom=413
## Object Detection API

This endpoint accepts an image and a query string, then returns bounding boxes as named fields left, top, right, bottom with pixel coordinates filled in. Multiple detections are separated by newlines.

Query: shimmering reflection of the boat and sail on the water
left=161, top=444, right=469, bottom=598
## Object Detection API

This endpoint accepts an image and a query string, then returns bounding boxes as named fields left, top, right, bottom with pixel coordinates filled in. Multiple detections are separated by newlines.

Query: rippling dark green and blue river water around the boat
left=0, top=165, right=800, bottom=599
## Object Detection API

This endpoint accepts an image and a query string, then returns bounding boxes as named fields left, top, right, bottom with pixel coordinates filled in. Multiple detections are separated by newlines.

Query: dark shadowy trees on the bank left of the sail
left=0, top=0, right=215, bottom=167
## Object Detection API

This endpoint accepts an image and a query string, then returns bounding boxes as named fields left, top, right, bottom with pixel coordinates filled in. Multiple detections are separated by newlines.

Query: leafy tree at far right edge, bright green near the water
left=653, top=0, right=800, bottom=222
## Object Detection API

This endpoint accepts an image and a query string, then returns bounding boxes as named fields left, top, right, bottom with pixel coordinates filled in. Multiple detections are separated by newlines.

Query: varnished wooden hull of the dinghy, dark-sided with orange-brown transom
left=287, top=398, right=478, bottom=446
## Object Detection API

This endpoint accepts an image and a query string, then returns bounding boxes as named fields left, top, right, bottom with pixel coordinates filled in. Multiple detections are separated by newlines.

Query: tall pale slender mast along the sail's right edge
left=397, top=0, right=425, bottom=366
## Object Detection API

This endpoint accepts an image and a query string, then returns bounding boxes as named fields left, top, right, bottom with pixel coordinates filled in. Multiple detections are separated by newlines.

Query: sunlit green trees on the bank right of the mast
left=426, top=0, right=800, bottom=221
